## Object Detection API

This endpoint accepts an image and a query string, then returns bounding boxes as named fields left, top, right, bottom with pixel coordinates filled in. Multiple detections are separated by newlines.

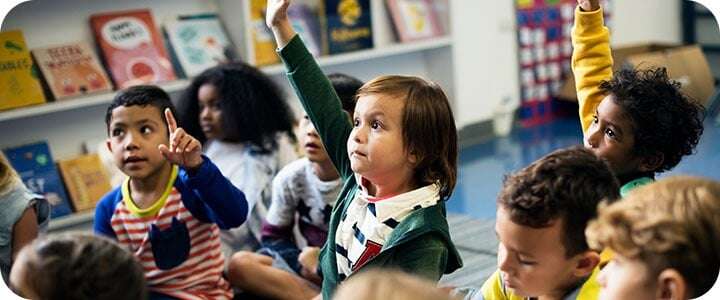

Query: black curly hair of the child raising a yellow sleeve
left=600, top=68, right=705, bottom=173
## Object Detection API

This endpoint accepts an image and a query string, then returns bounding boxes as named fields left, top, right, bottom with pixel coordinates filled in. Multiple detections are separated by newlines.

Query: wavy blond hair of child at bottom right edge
left=587, top=176, right=720, bottom=298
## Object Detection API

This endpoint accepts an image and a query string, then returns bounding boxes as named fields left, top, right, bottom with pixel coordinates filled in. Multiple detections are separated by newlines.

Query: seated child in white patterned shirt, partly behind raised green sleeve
left=228, top=73, right=363, bottom=299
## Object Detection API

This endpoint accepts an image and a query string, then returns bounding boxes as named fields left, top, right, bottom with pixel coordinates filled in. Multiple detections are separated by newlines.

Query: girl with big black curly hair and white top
left=178, top=62, right=297, bottom=255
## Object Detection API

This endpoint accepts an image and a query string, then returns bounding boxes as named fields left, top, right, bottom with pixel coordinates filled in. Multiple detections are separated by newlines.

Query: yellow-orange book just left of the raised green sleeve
left=250, top=0, right=280, bottom=66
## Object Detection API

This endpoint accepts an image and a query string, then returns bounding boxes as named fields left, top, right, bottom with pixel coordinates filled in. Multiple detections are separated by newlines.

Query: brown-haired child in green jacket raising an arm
left=266, top=0, right=461, bottom=299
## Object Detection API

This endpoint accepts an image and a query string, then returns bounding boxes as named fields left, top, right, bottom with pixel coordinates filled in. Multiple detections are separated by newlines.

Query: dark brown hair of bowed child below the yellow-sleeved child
left=497, top=147, right=620, bottom=257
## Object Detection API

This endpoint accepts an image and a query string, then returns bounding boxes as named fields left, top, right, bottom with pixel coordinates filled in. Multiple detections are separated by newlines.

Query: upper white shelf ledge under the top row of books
left=0, top=36, right=452, bottom=122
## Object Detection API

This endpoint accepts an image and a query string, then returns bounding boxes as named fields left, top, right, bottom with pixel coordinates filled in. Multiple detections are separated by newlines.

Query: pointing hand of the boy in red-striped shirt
left=158, top=108, right=203, bottom=171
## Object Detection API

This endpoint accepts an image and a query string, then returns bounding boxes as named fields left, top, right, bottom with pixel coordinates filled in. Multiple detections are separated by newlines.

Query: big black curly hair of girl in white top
left=178, top=62, right=295, bottom=152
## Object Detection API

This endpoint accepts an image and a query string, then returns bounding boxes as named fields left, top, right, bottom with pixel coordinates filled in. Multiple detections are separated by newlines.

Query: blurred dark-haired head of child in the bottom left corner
left=10, top=233, right=148, bottom=300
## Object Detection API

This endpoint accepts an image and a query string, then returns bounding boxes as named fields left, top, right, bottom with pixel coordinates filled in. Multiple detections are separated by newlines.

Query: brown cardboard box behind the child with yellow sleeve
left=557, top=43, right=715, bottom=105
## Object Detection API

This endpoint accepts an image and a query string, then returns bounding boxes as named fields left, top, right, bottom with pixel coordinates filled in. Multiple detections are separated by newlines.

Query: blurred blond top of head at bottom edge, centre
left=333, top=269, right=456, bottom=300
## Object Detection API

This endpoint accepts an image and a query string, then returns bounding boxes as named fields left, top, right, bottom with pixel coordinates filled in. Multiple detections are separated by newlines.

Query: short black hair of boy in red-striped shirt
left=105, top=85, right=177, bottom=135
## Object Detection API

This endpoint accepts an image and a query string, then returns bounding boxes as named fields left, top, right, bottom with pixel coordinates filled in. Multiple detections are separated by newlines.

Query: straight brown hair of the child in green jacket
left=357, top=75, right=458, bottom=200
